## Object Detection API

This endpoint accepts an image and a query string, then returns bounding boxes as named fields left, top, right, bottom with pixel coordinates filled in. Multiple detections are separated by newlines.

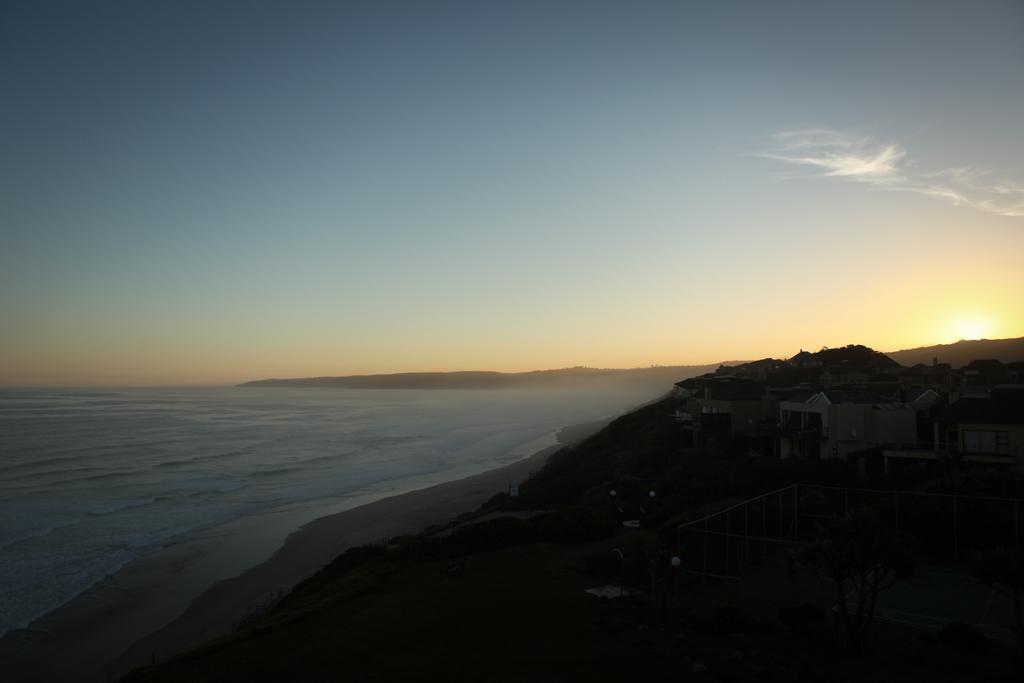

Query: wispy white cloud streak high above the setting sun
left=759, top=128, right=1024, bottom=217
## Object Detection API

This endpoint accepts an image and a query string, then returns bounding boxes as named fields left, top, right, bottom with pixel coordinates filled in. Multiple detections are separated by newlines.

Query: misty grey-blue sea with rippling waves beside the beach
left=0, top=385, right=656, bottom=634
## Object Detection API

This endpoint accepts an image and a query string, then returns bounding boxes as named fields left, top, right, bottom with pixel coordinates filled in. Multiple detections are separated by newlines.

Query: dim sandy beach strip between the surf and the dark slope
left=0, top=421, right=607, bottom=681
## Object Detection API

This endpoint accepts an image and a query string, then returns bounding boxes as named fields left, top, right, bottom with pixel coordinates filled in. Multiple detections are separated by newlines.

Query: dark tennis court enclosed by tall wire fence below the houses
left=676, top=484, right=1024, bottom=642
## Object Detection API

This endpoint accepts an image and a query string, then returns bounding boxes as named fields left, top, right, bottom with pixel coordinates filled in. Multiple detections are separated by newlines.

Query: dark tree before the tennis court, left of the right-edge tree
left=800, top=508, right=911, bottom=654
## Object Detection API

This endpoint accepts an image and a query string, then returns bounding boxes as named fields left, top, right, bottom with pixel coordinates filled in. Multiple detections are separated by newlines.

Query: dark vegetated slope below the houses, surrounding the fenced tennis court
left=127, top=401, right=1021, bottom=681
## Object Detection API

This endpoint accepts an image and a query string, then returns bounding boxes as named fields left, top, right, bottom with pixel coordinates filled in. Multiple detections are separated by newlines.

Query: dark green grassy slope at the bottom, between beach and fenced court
left=125, top=544, right=704, bottom=681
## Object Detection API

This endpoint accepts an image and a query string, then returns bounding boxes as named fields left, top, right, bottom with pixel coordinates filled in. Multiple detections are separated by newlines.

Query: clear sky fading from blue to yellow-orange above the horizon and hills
left=0, top=0, right=1024, bottom=386
